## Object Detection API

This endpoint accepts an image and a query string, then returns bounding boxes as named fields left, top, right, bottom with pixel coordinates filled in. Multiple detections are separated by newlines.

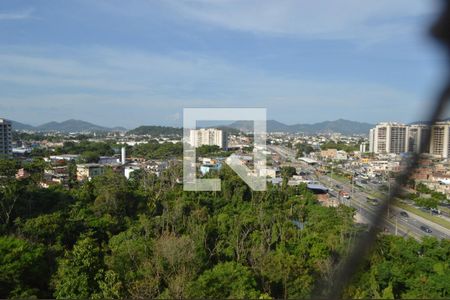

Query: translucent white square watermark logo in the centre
left=183, top=108, right=266, bottom=191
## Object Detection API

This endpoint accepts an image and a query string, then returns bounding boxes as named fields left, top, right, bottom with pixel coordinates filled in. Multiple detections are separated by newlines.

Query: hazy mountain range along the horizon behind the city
left=12, top=119, right=375, bottom=135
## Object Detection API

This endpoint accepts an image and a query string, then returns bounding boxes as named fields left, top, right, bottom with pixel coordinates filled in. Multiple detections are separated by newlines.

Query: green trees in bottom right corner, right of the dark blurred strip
left=344, top=236, right=450, bottom=299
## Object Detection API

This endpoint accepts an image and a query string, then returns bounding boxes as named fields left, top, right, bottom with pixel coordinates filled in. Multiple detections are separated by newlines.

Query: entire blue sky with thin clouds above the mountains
left=0, top=0, right=444, bottom=128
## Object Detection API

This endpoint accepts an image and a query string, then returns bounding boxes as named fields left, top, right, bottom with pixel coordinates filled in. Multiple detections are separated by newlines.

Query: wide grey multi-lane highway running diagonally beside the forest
left=267, top=145, right=450, bottom=239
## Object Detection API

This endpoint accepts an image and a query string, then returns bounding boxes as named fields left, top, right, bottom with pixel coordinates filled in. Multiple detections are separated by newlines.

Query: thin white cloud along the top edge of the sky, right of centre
left=166, top=0, right=434, bottom=40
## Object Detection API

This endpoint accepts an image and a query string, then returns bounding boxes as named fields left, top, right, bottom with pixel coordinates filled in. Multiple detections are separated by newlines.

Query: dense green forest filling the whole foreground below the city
left=0, top=160, right=450, bottom=299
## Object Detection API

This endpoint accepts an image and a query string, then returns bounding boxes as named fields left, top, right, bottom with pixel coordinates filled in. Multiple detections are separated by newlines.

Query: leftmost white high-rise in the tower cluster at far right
left=369, top=123, right=407, bottom=154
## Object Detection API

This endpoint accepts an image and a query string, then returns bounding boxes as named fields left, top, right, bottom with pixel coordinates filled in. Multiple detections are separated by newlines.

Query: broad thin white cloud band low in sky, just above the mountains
left=0, top=47, right=428, bottom=127
